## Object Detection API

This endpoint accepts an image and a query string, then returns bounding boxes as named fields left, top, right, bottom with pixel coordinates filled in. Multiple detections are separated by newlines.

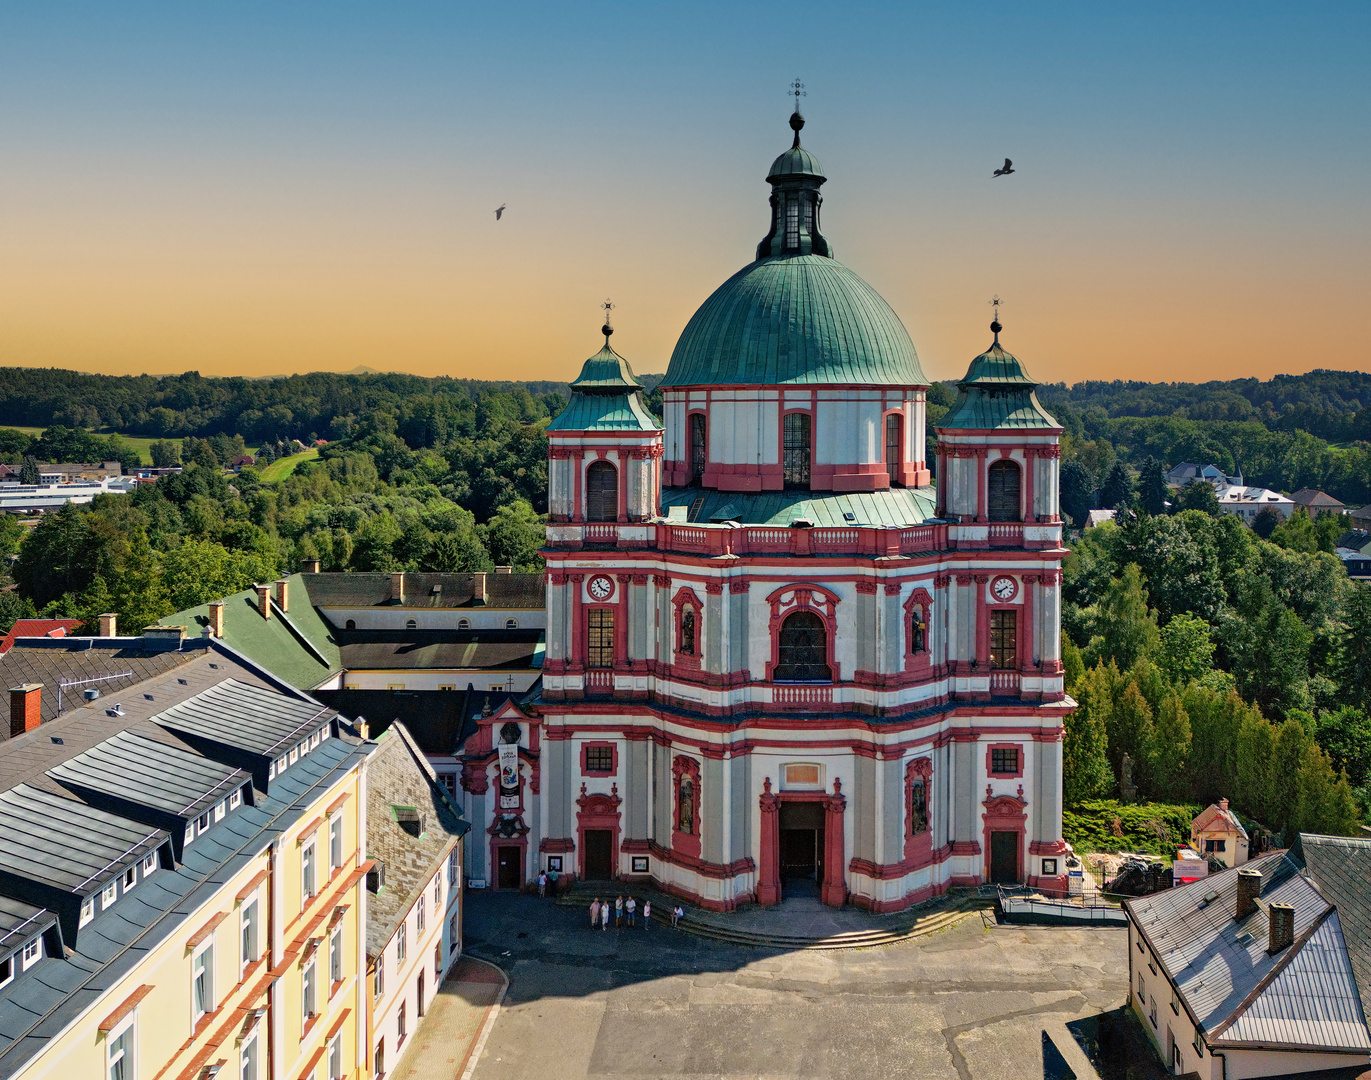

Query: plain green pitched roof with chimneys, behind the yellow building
left=170, top=574, right=343, bottom=689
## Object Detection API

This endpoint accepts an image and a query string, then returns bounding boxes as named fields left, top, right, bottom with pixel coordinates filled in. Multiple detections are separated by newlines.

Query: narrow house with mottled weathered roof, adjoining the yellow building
left=366, top=724, right=468, bottom=1076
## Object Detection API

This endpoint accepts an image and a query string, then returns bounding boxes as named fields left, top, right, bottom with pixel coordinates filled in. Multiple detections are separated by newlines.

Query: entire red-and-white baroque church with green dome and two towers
left=461, top=112, right=1073, bottom=911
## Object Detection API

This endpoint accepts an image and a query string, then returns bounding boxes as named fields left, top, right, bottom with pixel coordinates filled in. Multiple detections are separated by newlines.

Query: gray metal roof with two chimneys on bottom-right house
left=1124, top=851, right=1371, bottom=1053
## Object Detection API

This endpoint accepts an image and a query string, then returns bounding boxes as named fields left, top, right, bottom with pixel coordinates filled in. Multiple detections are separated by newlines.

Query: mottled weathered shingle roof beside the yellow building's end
left=366, top=724, right=470, bottom=957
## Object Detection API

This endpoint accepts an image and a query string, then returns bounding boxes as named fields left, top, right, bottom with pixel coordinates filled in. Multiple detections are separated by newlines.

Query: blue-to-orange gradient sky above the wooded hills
left=0, top=0, right=1371, bottom=381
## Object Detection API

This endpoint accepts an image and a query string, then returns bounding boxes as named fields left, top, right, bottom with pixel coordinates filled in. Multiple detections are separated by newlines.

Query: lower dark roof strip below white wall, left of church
left=337, top=629, right=546, bottom=672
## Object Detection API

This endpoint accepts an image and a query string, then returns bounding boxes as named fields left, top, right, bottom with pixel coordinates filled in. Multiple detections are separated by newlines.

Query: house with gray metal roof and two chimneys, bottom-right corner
left=1124, top=835, right=1371, bottom=1080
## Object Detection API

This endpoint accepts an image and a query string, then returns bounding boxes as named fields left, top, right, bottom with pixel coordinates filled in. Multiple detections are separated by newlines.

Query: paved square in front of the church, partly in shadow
left=466, top=892, right=1164, bottom=1080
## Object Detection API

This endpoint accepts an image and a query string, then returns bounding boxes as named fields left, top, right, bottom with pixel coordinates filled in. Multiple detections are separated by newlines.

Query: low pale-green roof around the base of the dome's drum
left=662, top=487, right=935, bottom=526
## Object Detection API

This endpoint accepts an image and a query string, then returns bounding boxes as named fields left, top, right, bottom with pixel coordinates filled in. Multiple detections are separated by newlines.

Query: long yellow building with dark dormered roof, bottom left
left=0, top=628, right=372, bottom=1080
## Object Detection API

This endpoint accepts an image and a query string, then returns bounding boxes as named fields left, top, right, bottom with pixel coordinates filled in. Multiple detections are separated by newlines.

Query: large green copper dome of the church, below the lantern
left=662, top=255, right=928, bottom=386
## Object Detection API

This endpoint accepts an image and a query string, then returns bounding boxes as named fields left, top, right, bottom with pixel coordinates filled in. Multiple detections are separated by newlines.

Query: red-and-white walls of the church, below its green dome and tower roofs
left=463, top=372, right=1072, bottom=911
